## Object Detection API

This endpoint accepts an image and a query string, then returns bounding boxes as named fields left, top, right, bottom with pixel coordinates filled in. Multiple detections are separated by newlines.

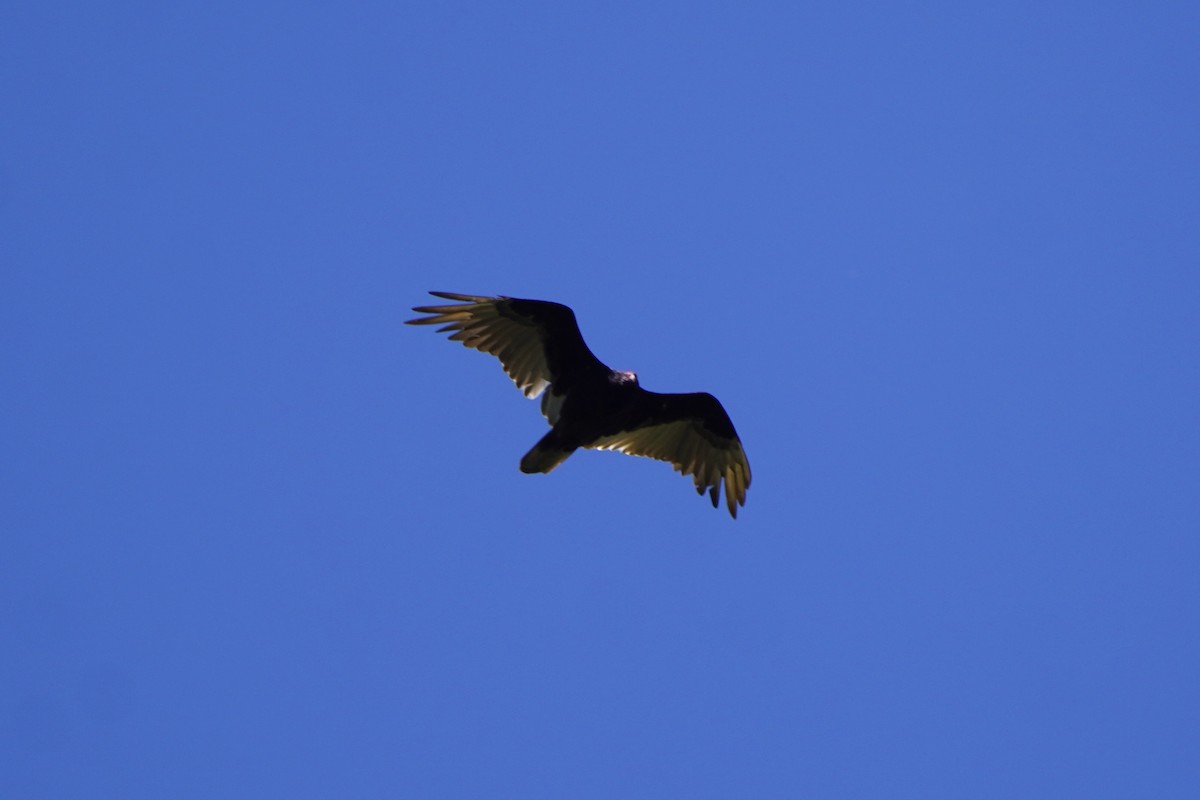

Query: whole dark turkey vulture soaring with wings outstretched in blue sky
left=408, top=291, right=750, bottom=519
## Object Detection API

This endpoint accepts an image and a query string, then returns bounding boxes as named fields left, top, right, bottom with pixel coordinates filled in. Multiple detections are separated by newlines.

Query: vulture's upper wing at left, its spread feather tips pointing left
left=408, top=291, right=605, bottom=397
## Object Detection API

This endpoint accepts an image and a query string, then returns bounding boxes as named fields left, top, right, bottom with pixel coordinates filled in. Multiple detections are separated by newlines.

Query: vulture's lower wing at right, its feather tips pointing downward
left=589, top=390, right=750, bottom=519
